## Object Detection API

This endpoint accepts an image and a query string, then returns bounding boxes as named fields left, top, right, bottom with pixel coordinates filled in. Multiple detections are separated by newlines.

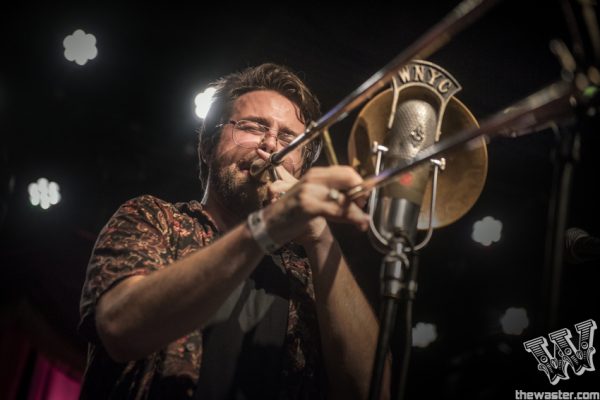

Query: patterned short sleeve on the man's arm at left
left=78, top=196, right=172, bottom=343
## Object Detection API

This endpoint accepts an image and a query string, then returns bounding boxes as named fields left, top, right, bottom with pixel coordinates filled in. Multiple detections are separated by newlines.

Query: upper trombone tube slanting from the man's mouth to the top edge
left=251, top=0, right=499, bottom=176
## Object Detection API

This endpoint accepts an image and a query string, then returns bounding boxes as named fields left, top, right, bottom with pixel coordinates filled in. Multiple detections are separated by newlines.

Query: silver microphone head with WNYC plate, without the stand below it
left=370, top=61, right=460, bottom=252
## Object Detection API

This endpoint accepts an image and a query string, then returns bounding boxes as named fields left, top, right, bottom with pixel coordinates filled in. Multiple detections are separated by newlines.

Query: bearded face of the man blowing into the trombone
left=209, top=90, right=304, bottom=218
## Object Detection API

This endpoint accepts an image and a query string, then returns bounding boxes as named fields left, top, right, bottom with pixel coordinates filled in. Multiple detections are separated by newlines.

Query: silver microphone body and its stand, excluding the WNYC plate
left=369, top=96, right=439, bottom=399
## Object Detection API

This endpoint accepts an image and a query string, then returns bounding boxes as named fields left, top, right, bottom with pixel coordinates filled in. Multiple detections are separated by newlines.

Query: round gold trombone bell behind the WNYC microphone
left=348, top=89, right=488, bottom=230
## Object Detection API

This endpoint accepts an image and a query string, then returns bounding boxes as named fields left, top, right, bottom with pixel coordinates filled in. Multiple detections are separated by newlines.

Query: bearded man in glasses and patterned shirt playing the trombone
left=80, top=64, right=378, bottom=399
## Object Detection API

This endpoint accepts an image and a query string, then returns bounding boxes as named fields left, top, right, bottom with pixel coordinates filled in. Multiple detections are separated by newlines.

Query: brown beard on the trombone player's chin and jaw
left=209, top=162, right=269, bottom=220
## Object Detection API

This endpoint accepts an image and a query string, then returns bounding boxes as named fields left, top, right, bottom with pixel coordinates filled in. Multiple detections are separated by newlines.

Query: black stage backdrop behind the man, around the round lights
left=0, top=0, right=600, bottom=398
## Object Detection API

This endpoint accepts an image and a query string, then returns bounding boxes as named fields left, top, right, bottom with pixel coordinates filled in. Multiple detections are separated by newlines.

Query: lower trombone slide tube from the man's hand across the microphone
left=347, top=81, right=576, bottom=200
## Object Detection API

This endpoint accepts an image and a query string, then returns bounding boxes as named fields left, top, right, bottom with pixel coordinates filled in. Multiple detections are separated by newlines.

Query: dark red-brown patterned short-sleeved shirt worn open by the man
left=79, top=195, right=324, bottom=399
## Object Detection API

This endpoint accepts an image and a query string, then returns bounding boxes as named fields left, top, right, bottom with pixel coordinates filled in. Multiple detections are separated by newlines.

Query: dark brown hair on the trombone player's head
left=198, top=63, right=322, bottom=190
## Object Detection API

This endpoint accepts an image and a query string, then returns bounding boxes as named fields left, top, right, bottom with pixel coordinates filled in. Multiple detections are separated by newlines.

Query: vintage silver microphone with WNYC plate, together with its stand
left=369, top=60, right=460, bottom=399
